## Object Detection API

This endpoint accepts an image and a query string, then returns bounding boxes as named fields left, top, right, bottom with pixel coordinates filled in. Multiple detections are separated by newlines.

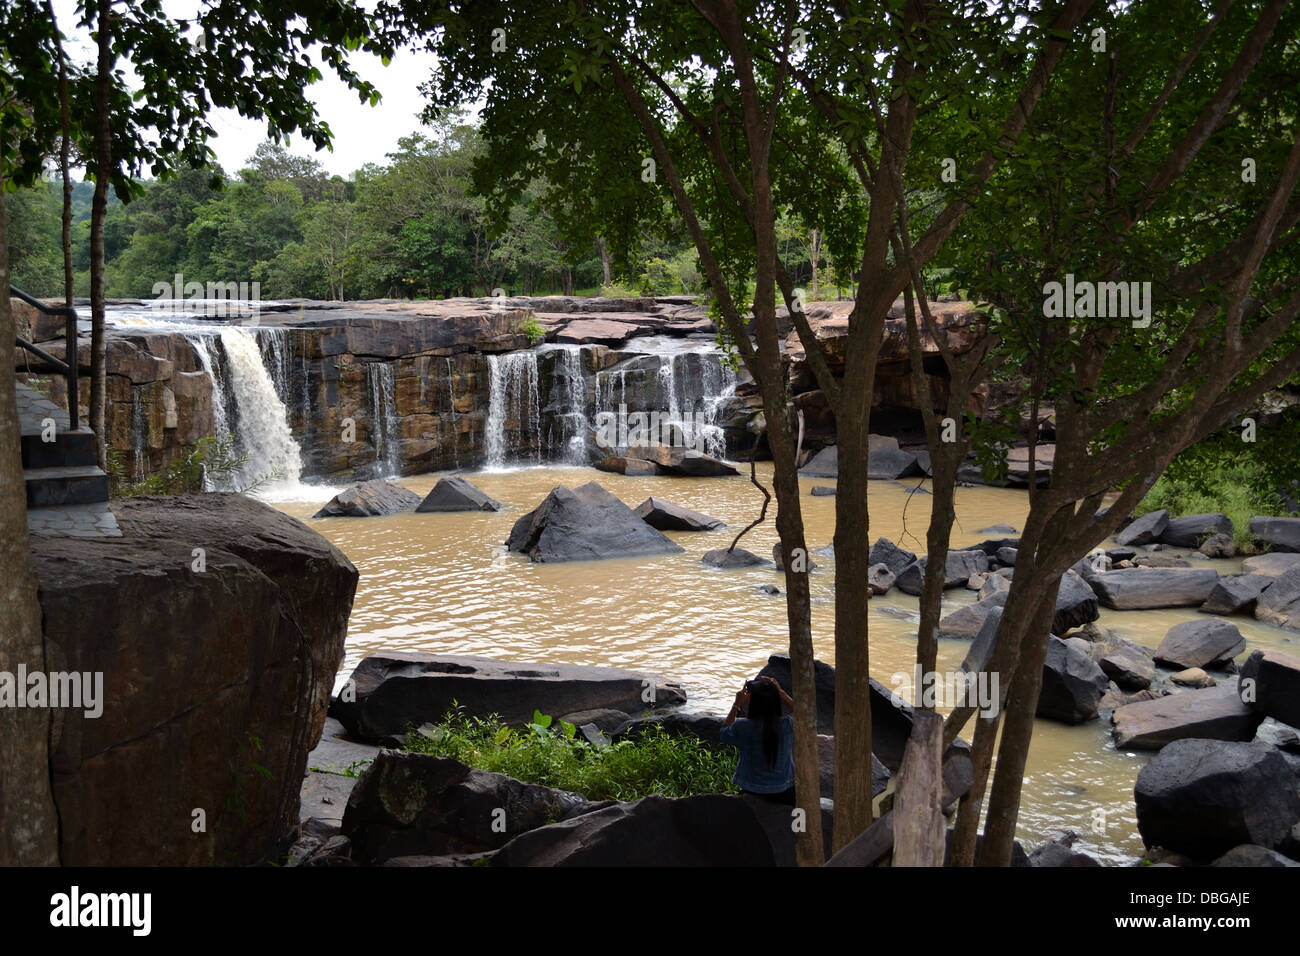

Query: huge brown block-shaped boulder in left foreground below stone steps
left=33, top=494, right=358, bottom=866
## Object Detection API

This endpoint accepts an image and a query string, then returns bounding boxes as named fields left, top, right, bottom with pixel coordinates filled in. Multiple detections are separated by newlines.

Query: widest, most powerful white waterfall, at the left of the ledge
left=187, top=325, right=302, bottom=490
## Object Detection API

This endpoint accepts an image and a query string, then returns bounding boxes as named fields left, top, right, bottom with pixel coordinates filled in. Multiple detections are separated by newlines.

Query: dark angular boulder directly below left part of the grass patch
left=342, top=750, right=586, bottom=864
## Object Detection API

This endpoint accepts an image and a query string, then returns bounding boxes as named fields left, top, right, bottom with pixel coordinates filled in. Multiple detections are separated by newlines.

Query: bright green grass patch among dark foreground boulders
left=407, top=709, right=737, bottom=800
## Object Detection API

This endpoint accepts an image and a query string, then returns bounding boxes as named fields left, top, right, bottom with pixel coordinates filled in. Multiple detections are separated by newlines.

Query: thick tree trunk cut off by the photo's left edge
left=0, top=181, right=59, bottom=866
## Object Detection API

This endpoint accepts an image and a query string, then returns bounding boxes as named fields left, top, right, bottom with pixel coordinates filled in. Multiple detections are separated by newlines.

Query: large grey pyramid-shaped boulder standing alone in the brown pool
left=506, top=481, right=683, bottom=563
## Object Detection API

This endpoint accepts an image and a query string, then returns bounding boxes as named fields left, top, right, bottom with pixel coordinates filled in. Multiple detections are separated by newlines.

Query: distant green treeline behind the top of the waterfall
left=9, top=124, right=833, bottom=299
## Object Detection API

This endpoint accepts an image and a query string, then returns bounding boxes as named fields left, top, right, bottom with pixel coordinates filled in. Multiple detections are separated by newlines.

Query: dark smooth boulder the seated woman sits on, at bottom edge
left=491, top=793, right=769, bottom=866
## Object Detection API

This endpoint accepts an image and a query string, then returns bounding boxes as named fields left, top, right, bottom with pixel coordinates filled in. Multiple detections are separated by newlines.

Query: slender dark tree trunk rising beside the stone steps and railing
left=88, top=0, right=113, bottom=471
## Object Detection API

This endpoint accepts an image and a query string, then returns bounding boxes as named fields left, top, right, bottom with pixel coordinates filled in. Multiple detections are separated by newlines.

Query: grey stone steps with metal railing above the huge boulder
left=16, top=382, right=122, bottom=537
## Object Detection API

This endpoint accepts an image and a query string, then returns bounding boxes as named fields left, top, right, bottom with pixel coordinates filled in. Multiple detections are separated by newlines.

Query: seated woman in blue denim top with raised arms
left=722, top=678, right=794, bottom=806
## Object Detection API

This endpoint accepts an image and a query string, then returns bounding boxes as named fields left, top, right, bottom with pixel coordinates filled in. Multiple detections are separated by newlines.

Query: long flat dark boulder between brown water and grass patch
left=330, top=650, right=686, bottom=740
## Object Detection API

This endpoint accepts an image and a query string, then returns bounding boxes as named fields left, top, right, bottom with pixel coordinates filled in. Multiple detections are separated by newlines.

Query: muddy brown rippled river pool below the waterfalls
left=276, top=464, right=1296, bottom=864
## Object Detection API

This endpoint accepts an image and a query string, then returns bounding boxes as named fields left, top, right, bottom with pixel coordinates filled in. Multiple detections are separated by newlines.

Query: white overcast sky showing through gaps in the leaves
left=55, top=0, right=444, bottom=177
